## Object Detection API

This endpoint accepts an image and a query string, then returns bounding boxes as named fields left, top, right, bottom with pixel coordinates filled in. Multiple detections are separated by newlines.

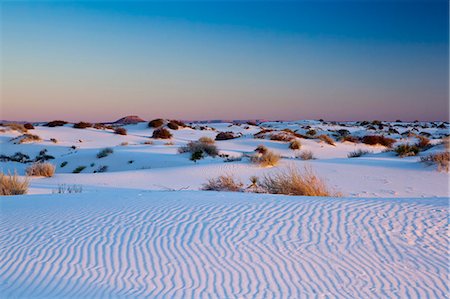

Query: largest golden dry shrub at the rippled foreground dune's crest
left=260, top=167, right=339, bottom=196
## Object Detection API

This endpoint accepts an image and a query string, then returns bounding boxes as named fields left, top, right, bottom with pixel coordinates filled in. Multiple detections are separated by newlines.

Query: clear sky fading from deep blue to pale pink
left=0, top=0, right=449, bottom=121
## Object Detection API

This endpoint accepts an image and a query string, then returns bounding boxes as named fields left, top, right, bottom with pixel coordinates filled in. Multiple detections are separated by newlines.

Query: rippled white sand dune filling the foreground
left=0, top=189, right=449, bottom=298
